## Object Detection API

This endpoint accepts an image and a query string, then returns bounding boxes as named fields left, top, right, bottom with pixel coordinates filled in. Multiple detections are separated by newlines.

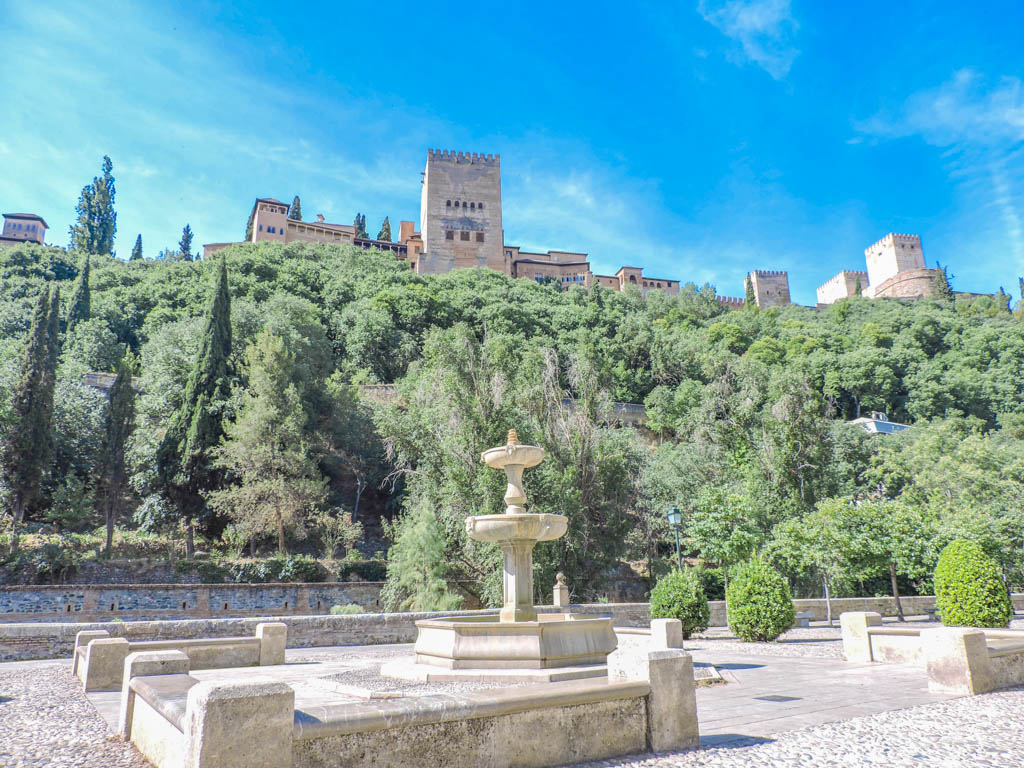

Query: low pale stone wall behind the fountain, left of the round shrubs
left=0, top=603, right=649, bottom=662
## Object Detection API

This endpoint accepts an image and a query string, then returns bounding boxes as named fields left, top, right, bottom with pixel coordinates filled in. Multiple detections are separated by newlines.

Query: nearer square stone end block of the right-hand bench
left=921, top=627, right=995, bottom=695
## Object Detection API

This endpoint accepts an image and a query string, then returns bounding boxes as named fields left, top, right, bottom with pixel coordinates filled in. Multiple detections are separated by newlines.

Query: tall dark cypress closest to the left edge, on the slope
left=0, top=290, right=59, bottom=552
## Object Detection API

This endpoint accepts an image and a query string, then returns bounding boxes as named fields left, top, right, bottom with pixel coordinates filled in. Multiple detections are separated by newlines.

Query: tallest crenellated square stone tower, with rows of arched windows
left=418, top=150, right=509, bottom=274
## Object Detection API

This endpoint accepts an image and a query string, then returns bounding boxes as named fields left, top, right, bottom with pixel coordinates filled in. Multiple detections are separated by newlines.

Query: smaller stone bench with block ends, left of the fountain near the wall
left=72, top=622, right=288, bottom=692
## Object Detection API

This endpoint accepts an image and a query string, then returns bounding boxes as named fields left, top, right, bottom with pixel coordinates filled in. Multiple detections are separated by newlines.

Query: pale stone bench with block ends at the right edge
left=840, top=612, right=1024, bottom=694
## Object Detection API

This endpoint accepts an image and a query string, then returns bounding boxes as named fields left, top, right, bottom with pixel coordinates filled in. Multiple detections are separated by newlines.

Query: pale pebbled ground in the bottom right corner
left=577, top=687, right=1024, bottom=768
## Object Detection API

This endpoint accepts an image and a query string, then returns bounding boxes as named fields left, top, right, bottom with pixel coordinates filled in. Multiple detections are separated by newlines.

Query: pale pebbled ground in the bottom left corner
left=0, top=664, right=152, bottom=768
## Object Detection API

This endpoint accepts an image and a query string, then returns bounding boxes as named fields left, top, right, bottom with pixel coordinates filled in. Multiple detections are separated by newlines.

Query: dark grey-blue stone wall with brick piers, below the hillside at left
left=0, top=582, right=384, bottom=623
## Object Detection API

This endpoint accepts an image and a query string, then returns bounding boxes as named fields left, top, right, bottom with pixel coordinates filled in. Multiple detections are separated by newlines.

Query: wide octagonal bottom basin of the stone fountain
left=415, top=613, right=617, bottom=674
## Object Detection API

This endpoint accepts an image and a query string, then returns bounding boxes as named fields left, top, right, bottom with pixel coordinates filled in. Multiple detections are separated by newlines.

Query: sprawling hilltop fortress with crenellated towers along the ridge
left=204, top=150, right=935, bottom=309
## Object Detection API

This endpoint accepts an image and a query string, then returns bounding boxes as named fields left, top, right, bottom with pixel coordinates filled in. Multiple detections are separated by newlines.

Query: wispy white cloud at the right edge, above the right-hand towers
left=855, top=69, right=1024, bottom=269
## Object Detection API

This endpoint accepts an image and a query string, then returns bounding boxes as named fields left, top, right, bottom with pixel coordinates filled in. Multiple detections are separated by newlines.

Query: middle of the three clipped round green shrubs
left=725, top=559, right=797, bottom=643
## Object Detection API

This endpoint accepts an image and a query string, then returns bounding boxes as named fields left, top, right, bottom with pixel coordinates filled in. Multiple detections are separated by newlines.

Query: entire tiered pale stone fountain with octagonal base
left=382, top=429, right=616, bottom=682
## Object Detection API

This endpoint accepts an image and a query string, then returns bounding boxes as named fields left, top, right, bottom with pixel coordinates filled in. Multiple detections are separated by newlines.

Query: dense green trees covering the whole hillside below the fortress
left=0, top=237, right=1024, bottom=607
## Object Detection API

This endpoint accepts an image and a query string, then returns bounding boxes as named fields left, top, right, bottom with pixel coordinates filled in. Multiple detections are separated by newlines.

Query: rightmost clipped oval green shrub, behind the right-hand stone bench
left=935, top=539, right=1014, bottom=627
